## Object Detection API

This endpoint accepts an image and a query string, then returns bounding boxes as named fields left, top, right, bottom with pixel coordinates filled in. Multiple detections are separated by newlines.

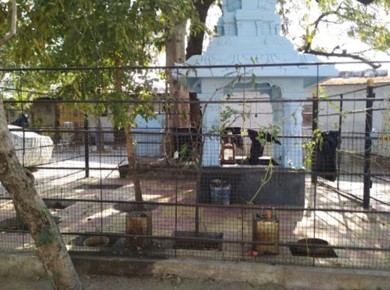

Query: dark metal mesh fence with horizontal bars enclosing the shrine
left=0, top=62, right=390, bottom=269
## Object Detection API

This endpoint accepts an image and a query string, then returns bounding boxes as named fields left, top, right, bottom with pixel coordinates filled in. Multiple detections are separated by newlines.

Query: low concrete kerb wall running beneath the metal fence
left=0, top=253, right=390, bottom=290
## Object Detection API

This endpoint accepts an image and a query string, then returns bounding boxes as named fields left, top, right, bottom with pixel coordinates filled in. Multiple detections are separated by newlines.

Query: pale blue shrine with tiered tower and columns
left=181, top=0, right=338, bottom=168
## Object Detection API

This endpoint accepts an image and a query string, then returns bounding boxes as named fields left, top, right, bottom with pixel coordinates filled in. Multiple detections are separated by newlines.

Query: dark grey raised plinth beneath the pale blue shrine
left=198, top=165, right=305, bottom=206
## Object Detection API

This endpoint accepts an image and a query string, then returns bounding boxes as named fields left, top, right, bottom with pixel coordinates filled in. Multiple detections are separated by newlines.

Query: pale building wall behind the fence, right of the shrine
left=306, top=80, right=390, bottom=157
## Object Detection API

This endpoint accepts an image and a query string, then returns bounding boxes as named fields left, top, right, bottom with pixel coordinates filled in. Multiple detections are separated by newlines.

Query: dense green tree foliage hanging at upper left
left=0, top=0, right=193, bottom=127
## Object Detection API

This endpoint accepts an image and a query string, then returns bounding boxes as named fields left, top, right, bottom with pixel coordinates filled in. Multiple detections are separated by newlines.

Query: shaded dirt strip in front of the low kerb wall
left=0, top=276, right=290, bottom=290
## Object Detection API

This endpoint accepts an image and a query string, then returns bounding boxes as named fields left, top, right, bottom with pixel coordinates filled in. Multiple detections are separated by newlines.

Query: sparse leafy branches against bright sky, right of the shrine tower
left=280, top=0, right=390, bottom=60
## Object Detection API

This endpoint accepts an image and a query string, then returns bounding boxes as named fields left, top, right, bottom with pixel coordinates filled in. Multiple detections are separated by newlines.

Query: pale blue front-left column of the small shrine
left=198, top=95, right=221, bottom=167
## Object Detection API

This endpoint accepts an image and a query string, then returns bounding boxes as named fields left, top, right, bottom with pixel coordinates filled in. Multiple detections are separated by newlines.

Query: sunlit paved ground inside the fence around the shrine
left=0, top=150, right=390, bottom=269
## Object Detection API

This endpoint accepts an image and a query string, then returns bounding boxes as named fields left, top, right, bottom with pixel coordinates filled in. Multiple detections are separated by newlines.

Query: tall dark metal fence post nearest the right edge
left=363, top=79, right=375, bottom=209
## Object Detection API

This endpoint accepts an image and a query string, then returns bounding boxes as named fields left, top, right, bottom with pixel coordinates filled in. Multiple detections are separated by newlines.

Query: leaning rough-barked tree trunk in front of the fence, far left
left=0, top=97, right=82, bottom=290
